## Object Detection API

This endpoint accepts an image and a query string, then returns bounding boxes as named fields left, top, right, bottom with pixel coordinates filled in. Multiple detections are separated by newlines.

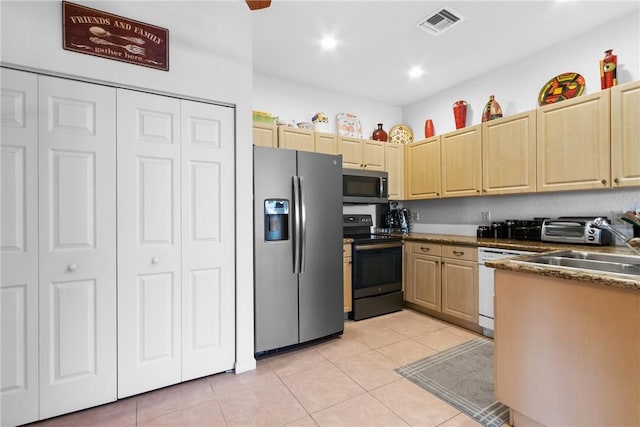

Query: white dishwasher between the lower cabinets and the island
left=478, top=247, right=533, bottom=337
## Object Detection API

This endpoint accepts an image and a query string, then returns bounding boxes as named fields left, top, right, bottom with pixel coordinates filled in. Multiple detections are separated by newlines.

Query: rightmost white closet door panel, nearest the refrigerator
left=181, top=101, right=235, bottom=381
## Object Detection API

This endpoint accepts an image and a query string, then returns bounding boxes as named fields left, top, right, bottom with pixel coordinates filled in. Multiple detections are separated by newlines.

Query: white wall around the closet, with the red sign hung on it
left=0, top=0, right=255, bottom=372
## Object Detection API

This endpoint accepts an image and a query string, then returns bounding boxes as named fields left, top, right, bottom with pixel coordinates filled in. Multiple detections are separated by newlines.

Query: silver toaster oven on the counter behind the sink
left=542, top=216, right=614, bottom=246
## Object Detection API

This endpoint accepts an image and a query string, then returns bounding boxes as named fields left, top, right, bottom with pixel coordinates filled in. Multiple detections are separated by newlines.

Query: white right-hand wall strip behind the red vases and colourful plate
left=403, top=12, right=640, bottom=135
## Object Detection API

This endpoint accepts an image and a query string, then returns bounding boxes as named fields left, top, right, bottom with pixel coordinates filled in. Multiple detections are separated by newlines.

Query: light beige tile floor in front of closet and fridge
left=28, top=310, right=480, bottom=427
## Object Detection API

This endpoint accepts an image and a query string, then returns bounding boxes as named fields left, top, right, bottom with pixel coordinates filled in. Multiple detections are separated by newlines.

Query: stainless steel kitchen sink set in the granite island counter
left=512, top=251, right=640, bottom=277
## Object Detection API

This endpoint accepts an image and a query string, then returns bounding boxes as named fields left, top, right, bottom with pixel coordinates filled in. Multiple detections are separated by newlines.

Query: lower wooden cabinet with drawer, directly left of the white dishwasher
left=442, top=245, right=478, bottom=323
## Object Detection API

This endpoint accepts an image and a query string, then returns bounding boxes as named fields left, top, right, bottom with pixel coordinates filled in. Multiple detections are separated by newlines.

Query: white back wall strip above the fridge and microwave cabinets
left=253, top=72, right=402, bottom=138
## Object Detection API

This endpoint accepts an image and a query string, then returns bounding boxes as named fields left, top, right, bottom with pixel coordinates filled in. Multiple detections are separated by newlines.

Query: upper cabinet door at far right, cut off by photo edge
left=611, top=81, right=640, bottom=187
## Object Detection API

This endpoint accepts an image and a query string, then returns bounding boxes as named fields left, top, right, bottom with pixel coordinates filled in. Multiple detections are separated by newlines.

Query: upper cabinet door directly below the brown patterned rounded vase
left=482, top=110, right=536, bottom=195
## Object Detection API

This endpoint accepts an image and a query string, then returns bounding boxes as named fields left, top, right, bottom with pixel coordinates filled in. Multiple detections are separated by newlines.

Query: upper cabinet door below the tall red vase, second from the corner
left=440, top=125, right=482, bottom=197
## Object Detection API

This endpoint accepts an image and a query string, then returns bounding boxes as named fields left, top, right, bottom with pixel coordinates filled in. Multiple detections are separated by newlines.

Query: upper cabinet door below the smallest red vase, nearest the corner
left=405, top=136, right=441, bottom=200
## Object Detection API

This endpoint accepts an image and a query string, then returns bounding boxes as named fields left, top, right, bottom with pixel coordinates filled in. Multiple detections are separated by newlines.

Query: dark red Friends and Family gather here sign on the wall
left=62, top=1, right=169, bottom=71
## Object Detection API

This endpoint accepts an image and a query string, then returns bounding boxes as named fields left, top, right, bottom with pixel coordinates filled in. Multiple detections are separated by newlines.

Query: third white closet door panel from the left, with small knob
left=118, top=89, right=181, bottom=397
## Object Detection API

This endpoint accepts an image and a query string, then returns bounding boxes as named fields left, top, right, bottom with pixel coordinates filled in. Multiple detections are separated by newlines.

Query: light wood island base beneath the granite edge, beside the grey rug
left=490, top=260, right=640, bottom=426
